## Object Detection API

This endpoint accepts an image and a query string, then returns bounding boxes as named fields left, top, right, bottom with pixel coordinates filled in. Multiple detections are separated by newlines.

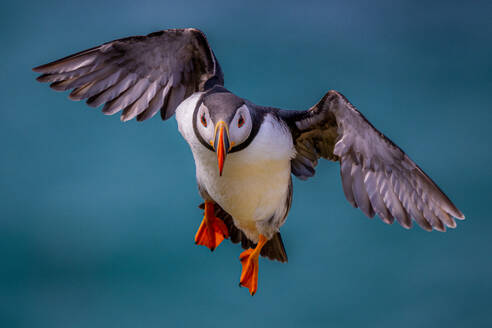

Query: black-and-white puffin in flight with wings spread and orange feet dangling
left=33, top=28, right=465, bottom=295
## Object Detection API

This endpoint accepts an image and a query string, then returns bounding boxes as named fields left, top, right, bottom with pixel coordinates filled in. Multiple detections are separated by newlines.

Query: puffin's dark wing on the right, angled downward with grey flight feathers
left=279, top=91, right=465, bottom=231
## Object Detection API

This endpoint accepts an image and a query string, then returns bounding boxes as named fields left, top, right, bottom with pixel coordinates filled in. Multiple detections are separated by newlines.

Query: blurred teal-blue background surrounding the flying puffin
left=0, top=0, right=492, bottom=328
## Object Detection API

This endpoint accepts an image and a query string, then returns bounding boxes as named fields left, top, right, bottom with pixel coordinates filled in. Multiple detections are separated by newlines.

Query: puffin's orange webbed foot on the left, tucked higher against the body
left=195, top=200, right=229, bottom=251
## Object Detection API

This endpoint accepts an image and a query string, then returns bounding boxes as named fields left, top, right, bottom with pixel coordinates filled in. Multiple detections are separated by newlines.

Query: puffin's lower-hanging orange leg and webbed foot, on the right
left=239, top=234, right=268, bottom=295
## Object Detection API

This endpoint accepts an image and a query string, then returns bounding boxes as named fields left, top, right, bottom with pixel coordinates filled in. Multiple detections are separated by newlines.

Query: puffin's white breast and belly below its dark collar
left=176, top=95, right=295, bottom=241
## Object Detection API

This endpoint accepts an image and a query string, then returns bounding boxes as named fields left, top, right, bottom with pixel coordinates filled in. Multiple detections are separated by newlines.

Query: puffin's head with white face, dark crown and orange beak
left=193, top=88, right=253, bottom=175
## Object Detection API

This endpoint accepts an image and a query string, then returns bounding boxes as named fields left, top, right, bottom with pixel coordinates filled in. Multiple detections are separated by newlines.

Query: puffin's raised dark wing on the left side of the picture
left=33, top=28, right=224, bottom=121
